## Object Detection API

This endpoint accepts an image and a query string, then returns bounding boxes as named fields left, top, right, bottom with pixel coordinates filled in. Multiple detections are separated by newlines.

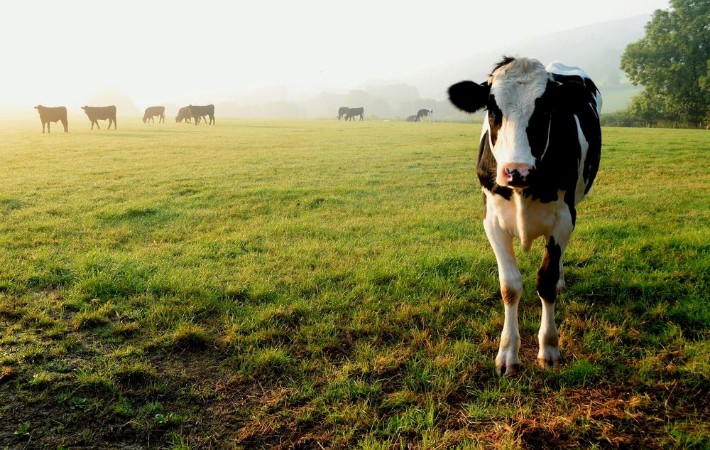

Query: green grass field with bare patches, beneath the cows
left=0, top=117, right=710, bottom=450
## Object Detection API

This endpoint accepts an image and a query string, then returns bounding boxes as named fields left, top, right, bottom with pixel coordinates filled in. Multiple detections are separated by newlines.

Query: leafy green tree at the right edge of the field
left=621, top=0, right=710, bottom=126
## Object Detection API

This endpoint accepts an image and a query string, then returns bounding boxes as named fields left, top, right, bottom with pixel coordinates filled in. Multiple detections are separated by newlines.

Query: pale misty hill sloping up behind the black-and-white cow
left=217, top=15, right=650, bottom=120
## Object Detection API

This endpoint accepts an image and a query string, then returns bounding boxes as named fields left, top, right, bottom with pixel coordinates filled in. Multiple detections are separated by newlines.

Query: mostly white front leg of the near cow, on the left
left=483, top=213, right=523, bottom=375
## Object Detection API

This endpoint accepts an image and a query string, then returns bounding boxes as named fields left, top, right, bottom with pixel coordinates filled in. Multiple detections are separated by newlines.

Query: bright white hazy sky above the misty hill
left=0, top=0, right=669, bottom=107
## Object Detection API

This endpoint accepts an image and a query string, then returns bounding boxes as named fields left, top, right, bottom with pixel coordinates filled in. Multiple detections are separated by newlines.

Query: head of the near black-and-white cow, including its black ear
left=449, top=57, right=557, bottom=187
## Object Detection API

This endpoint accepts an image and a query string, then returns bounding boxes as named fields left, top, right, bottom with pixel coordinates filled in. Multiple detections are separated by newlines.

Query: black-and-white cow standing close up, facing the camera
left=448, top=57, right=602, bottom=375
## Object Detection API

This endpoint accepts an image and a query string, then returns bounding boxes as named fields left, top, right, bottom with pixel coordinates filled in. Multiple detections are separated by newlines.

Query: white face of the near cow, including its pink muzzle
left=482, top=59, right=549, bottom=187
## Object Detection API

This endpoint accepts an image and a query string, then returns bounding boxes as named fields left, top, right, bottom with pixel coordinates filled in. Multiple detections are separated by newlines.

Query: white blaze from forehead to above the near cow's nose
left=489, top=58, right=548, bottom=176
